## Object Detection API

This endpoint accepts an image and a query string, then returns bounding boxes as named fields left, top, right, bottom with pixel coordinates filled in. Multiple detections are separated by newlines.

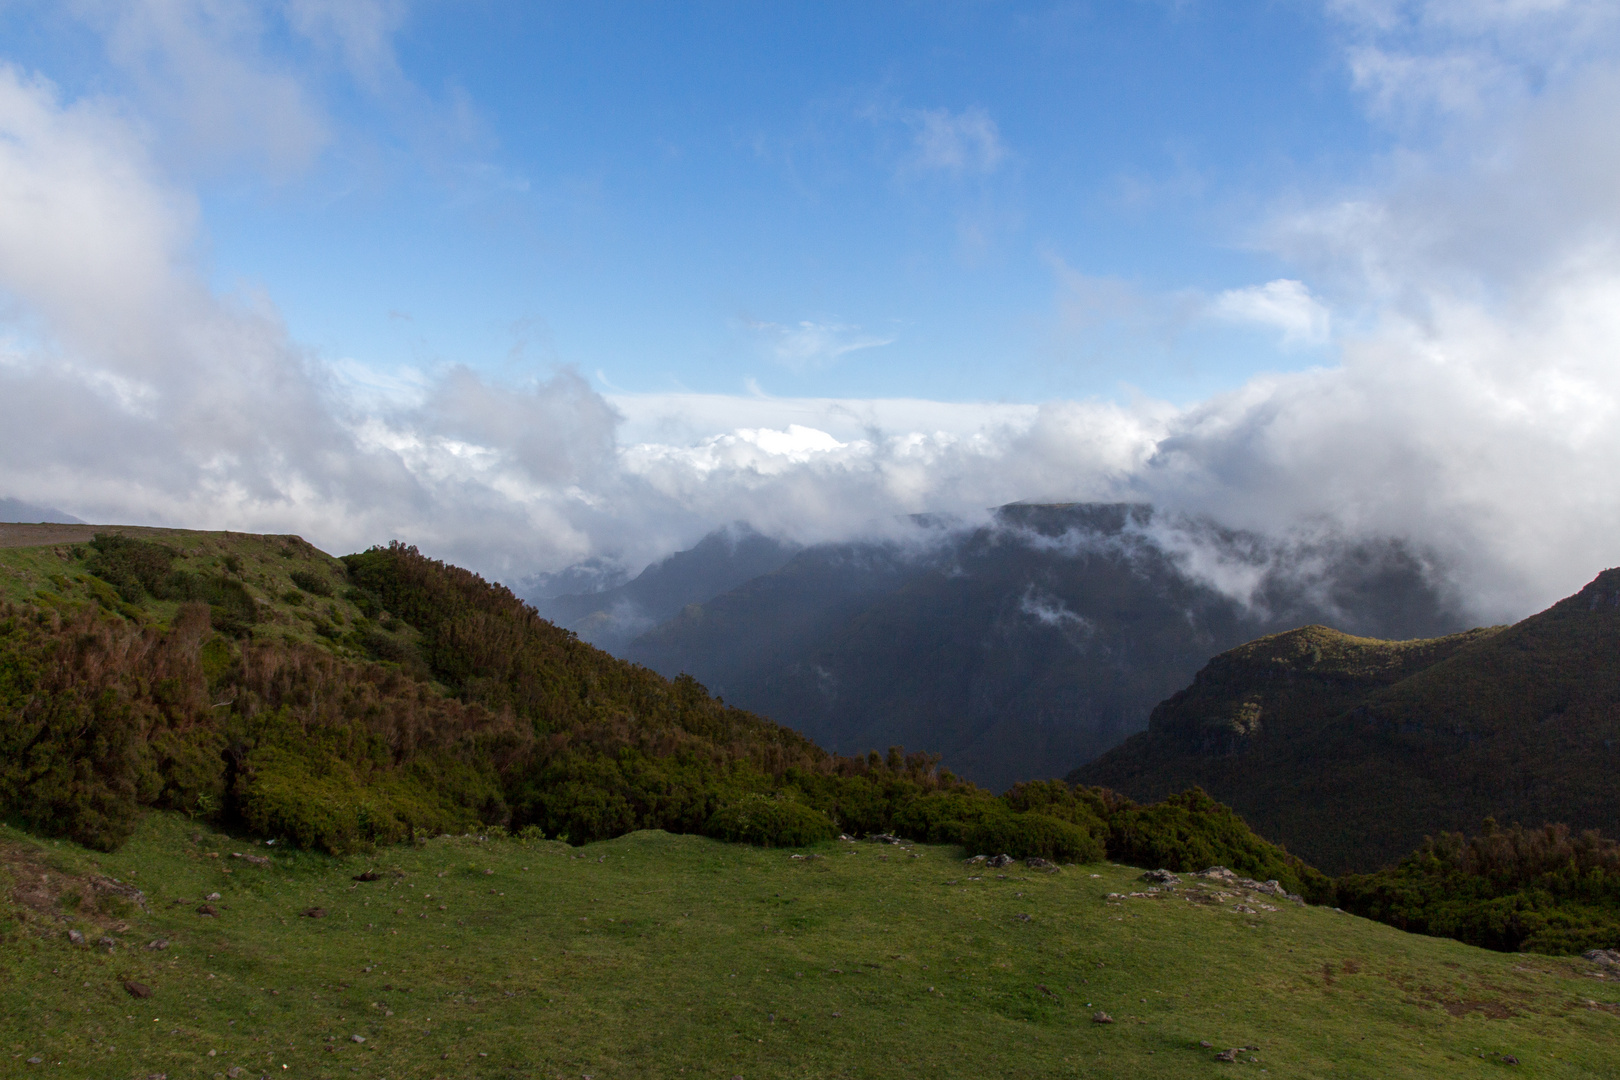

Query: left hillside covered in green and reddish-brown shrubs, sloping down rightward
left=0, top=531, right=1330, bottom=899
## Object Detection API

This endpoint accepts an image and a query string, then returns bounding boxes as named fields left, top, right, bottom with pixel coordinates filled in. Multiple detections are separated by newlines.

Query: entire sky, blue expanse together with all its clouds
left=0, top=0, right=1620, bottom=620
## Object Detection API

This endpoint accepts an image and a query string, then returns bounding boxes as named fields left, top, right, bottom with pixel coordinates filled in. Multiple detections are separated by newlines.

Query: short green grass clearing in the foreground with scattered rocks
left=0, top=814, right=1620, bottom=1080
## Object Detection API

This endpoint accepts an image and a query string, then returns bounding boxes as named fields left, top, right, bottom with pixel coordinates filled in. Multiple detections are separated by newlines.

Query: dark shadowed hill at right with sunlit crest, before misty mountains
left=1069, top=570, right=1620, bottom=871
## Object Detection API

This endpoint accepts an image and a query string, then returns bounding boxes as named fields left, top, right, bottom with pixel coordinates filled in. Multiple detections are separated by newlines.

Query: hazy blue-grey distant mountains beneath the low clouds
left=624, top=504, right=1463, bottom=789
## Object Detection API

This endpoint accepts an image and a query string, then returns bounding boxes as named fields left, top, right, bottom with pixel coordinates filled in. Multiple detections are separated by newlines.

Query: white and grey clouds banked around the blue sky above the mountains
left=0, top=0, right=1620, bottom=620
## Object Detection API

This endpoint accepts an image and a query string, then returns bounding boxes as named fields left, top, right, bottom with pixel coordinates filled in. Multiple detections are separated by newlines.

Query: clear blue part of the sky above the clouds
left=5, top=0, right=1380, bottom=402
